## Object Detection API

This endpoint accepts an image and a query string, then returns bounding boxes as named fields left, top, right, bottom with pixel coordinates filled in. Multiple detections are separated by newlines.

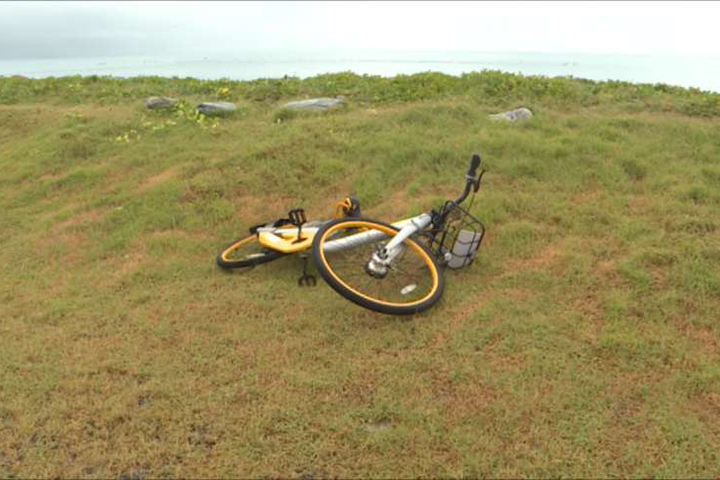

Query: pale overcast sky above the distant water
left=0, top=1, right=720, bottom=59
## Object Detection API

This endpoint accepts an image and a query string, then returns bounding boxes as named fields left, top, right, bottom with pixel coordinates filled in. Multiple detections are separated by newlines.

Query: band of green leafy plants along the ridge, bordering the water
left=0, top=70, right=720, bottom=117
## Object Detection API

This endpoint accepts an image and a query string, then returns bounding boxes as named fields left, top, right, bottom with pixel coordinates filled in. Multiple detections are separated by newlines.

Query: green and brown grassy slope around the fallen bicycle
left=0, top=72, right=720, bottom=478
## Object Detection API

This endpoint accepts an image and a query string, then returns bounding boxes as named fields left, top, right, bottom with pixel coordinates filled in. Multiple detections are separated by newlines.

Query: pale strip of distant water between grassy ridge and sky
left=0, top=51, right=720, bottom=92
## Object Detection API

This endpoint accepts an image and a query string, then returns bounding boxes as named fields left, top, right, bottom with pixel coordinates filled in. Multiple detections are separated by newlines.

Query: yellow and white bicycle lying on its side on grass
left=217, top=154, right=485, bottom=315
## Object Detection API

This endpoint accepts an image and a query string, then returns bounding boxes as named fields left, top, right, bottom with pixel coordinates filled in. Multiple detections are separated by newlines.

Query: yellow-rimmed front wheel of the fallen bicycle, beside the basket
left=313, top=218, right=445, bottom=315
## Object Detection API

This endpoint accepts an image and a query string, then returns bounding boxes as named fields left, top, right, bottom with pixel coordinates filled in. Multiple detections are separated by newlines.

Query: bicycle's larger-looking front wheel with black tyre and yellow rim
left=313, top=218, right=445, bottom=315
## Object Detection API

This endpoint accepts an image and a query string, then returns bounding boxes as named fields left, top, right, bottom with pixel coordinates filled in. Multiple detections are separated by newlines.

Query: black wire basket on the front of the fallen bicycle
left=430, top=201, right=485, bottom=269
